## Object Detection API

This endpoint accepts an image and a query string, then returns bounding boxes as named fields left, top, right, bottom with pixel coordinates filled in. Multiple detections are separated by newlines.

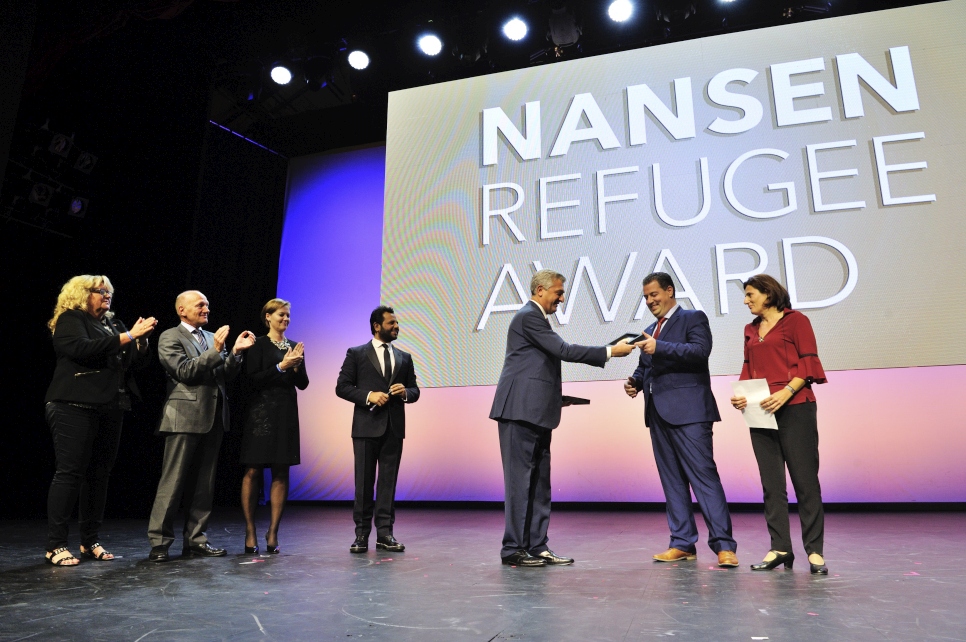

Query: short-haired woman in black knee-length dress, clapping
left=241, top=299, right=309, bottom=555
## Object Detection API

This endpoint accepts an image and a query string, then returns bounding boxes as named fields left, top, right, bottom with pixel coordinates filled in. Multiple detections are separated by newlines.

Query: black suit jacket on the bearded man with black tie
left=335, top=341, right=419, bottom=438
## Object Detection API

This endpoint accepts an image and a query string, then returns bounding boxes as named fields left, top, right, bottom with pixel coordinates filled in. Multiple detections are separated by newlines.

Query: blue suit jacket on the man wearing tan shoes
left=633, top=307, right=721, bottom=426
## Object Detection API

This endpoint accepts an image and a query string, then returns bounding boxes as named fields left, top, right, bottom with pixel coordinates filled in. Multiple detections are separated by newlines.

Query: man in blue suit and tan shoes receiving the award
left=624, top=272, right=738, bottom=567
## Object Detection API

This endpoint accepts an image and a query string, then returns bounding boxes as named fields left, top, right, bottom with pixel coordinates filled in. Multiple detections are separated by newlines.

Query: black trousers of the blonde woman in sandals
left=44, top=401, right=124, bottom=551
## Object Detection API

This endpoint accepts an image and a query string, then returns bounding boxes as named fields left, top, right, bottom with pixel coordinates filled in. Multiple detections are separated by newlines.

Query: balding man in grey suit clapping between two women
left=148, top=290, right=255, bottom=562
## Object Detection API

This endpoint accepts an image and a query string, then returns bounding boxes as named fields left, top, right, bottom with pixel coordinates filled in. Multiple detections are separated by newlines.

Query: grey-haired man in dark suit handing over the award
left=490, top=270, right=634, bottom=566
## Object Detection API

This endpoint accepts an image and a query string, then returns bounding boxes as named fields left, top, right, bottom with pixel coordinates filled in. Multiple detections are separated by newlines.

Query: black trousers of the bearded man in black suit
left=352, top=426, right=403, bottom=537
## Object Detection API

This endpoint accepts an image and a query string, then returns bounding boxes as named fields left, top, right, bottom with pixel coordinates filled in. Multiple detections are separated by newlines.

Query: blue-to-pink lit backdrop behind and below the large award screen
left=278, top=147, right=966, bottom=502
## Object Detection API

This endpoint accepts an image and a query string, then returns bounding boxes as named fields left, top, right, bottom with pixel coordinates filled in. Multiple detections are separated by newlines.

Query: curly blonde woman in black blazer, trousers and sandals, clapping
left=45, top=274, right=157, bottom=566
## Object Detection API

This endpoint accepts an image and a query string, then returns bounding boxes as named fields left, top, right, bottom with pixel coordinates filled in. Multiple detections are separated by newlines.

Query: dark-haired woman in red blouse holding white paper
left=731, top=274, right=828, bottom=575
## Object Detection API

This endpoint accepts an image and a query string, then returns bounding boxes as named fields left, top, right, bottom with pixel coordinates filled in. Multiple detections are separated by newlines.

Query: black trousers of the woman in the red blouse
left=751, top=402, right=825, bottom=555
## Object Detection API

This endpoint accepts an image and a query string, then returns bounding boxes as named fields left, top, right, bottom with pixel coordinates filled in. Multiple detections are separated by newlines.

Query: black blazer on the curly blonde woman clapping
left=44, top=310, right=141, bottom=405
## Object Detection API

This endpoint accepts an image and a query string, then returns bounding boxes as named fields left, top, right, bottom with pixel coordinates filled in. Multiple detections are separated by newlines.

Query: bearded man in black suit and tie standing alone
left=335, top=305, right=419, bottom=553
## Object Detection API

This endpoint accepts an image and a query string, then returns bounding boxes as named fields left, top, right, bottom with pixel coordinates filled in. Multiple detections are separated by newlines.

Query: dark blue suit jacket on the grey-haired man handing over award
left=490, top=301, right=607, bottom=430
